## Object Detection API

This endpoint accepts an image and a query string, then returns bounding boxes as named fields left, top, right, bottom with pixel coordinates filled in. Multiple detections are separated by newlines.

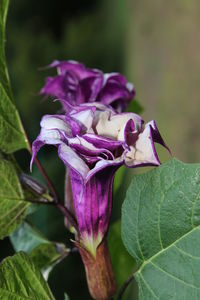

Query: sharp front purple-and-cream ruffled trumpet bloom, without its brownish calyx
left=31, top=102, right=169, bottom=256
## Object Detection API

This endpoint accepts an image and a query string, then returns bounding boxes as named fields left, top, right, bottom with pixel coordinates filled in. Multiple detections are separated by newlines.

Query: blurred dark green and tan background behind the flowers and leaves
left=0, top=0, right=200, bottom=300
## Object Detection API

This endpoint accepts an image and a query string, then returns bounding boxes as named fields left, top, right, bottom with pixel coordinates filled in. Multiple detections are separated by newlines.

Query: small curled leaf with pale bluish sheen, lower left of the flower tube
left=10, top=222, right=69, bottom=279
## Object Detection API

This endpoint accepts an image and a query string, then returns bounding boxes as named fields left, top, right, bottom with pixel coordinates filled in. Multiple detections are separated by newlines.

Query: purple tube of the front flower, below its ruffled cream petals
left=71, top=166, right=117, bottom=253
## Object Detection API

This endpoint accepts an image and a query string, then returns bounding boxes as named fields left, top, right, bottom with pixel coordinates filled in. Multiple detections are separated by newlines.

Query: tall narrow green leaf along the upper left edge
left=0, top=0, right=29, bottom=154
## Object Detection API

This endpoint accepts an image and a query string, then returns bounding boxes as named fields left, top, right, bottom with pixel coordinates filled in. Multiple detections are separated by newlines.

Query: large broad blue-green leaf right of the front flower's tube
left=122, top=159, right=200, bottom=300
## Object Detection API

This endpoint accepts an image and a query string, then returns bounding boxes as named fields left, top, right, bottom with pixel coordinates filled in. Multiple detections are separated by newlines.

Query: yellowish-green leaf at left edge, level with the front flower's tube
left=0, top=159, right=30, bottom=239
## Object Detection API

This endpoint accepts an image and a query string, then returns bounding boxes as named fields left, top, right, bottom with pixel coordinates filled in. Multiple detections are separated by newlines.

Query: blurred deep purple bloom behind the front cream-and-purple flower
left=41, top=61, right=135, bottom=111
